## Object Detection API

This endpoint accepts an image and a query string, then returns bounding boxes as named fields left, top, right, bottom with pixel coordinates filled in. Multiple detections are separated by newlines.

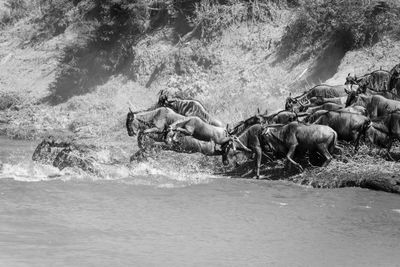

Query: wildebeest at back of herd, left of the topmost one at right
left=285, top=84, right=347, bottom=112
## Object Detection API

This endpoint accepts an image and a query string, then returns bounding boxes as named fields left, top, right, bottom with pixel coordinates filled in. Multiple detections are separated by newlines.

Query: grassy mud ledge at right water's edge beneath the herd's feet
left=223, top=145, right=400, bottom=194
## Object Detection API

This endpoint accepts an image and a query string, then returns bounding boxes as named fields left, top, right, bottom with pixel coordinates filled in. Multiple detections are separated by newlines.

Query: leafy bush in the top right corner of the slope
left=280, top=0, right=400, bottom=58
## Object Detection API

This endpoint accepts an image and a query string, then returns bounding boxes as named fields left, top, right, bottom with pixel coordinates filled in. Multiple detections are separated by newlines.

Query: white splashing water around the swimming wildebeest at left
left=0, top=138, right=225, bottom=188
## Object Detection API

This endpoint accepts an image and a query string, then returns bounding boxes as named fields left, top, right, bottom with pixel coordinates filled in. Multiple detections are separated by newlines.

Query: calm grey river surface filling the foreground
left=0, top=138, right=400, bottom=266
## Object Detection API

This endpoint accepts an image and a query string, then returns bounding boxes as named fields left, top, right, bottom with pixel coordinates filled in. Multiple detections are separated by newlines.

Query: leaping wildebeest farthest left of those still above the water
left=126, top=107, right=186, bottom=136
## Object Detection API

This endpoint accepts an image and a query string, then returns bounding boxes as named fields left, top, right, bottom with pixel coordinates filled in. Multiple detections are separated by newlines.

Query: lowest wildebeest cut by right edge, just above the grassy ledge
left=366, top=111, right=400, bottom=160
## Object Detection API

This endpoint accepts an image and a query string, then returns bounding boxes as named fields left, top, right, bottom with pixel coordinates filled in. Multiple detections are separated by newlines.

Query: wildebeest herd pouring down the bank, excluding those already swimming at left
left=126, top=64, right=400, bottom=178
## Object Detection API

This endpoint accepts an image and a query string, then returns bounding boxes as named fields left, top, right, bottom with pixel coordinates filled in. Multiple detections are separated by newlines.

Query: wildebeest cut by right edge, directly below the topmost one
left=346, top=92, right=400, bottom=119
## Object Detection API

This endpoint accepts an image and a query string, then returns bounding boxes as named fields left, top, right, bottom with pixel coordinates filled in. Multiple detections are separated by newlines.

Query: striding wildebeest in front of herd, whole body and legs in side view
left=262, top=122, right=340, bottom=171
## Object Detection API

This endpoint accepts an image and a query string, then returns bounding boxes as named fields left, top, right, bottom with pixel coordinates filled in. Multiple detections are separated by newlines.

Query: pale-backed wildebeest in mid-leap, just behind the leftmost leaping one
left=168, top=117, right=231, bottom=145
